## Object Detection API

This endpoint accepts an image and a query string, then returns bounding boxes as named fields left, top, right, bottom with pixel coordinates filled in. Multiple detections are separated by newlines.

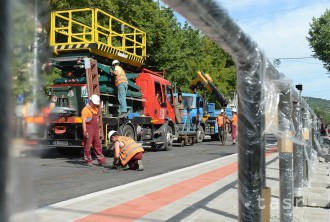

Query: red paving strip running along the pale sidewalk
left=76, top=149, right=276, bottom=222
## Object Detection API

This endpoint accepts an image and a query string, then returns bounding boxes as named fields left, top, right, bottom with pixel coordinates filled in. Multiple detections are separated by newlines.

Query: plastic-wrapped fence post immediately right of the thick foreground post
left=278, top=90, right=293, bottom=222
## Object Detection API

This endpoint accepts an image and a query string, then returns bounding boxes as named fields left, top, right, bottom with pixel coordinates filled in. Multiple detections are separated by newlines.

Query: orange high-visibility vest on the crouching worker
left=118, top=136, right=144, bottom=166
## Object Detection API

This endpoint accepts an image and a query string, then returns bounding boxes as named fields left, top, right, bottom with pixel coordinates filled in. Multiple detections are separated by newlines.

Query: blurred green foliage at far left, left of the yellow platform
left=11, top=0, right=55, bottom=105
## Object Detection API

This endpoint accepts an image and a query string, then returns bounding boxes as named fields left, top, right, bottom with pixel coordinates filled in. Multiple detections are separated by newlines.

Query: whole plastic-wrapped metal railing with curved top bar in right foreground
left=163, top=0, right=318, bottom=222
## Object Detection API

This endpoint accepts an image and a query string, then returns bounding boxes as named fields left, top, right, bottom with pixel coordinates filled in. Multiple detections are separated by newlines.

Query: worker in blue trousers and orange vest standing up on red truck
left=112, top=60, right=128, bottom=116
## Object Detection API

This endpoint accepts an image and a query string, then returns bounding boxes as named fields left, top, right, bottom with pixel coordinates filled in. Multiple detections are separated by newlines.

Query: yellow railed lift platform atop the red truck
left=50, top=8, right=146, bottom=67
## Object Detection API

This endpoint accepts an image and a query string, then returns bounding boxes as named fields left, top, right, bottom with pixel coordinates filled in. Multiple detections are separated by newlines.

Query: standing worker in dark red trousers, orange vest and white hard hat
left=81, top=94, right=106, bottom=166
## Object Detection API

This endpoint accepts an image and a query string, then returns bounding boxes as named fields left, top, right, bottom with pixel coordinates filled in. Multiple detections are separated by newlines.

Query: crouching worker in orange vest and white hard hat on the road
left=108, top=130, right=144, bottom=171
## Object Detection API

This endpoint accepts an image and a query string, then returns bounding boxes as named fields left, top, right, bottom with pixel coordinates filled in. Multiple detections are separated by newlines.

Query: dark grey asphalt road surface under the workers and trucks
left=11, top=136, right=237, bottom=208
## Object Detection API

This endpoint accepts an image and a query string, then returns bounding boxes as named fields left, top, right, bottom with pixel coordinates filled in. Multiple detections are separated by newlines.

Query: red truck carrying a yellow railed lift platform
left=43, top=8, right=178, bottom=154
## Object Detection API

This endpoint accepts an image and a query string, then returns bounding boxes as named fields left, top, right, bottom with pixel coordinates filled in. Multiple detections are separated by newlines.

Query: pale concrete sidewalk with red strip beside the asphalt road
left=12, top=148, right=330, bottom=222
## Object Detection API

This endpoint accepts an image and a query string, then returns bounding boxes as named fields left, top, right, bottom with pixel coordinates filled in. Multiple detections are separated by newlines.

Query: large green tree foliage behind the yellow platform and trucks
left=13, top=0, right=236, bottom=106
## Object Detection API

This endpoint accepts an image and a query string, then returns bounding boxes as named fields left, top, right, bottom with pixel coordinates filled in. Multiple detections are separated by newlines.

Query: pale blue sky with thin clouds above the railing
left=161, top=0, right=330, bottom=100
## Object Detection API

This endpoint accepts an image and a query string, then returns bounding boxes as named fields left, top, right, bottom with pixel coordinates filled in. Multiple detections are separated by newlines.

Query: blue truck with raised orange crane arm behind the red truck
left=175, top=72, right=231, bottom=146
